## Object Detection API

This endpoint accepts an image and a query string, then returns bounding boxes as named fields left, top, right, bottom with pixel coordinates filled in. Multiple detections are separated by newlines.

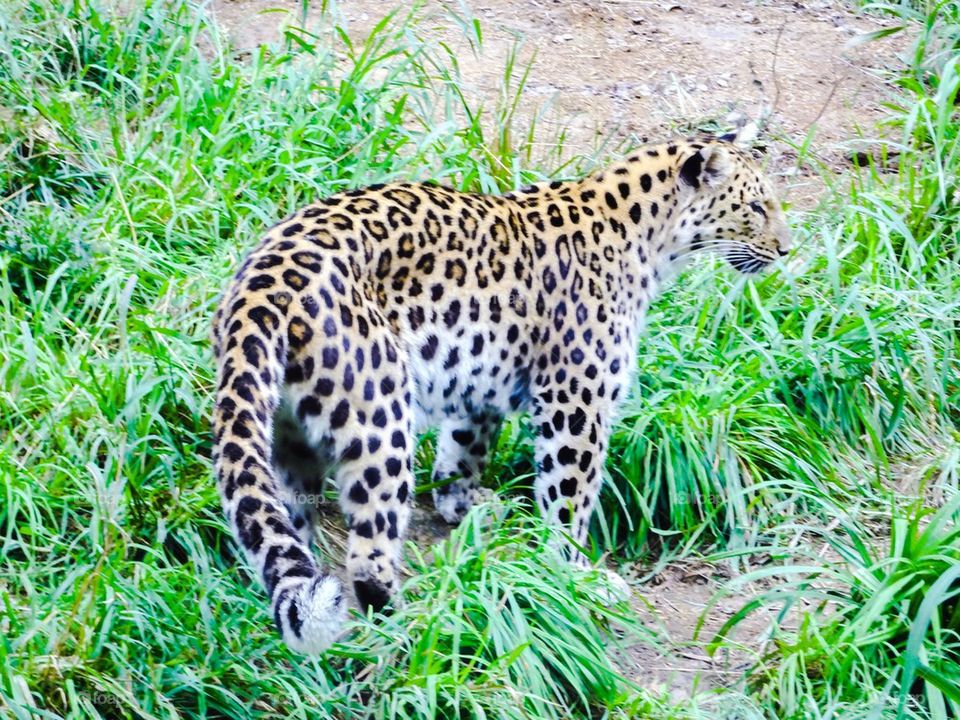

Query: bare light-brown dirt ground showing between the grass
left=211, top=0, right=910, bottom=696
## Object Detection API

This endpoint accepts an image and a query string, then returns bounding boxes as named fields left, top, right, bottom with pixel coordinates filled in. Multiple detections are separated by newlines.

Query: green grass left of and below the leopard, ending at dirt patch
left=0, top=2, right=686, bottom=718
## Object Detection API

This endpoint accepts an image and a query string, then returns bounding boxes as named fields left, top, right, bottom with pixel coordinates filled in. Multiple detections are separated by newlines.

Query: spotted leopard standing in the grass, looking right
left=212, top=129, right=791, bottom=655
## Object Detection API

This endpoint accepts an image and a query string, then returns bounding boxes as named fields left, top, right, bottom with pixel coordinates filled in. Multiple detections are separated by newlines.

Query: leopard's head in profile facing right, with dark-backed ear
left=673, top=131, right=791, bottom=273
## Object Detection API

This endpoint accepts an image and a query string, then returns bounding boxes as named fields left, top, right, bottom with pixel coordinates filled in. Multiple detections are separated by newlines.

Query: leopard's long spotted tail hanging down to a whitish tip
left=213, top=278, right=346, bottom=654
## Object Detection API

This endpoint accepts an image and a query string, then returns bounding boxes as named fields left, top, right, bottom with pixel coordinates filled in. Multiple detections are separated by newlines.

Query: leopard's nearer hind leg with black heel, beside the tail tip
left=287, top=308, right=414, bottom=610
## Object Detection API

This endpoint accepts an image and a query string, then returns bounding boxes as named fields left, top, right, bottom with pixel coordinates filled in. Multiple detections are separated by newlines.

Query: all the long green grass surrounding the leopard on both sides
left=0, top=0, right=960, bottom=719
